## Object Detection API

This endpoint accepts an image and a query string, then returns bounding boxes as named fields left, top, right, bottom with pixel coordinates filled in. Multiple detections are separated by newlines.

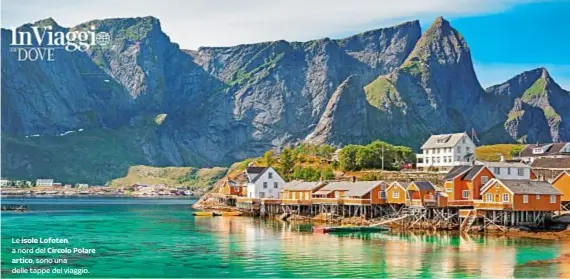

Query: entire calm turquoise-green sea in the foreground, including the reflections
left=1, top=198, right=570, bottom=278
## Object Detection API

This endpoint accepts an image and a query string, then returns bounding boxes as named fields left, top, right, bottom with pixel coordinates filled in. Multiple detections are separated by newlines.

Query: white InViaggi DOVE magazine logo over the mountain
left=10, top=25, right=111, bottom=61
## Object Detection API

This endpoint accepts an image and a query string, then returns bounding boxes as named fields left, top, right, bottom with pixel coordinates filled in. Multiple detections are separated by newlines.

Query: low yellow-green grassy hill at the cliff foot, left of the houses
left=111, top=166, right=228, bottom=188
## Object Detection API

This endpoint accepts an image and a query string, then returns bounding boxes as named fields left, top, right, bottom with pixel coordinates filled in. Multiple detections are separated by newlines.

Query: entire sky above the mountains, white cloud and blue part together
left=0, top=0, right=570, bottom=90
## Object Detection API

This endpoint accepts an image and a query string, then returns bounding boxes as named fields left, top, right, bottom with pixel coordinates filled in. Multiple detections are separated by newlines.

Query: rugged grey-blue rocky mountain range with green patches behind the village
left=2, top=17, right=570, bottom=183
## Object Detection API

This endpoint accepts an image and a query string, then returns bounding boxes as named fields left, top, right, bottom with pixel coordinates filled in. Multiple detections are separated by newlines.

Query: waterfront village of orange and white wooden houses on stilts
left=200, top=133, right=570, bottom=231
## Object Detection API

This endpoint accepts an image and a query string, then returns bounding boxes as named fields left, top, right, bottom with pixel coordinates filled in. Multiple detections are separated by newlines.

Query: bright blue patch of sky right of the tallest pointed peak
left=450, top=1, right=570, bottom=90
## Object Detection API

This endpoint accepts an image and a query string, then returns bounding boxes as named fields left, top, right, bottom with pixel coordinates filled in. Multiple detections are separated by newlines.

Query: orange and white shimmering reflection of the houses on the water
left=195, top=217, right=570, bottom=278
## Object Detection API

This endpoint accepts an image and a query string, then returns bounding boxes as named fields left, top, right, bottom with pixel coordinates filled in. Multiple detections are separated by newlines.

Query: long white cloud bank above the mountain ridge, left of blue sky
left=2, top=0, right=528, bottom=49
